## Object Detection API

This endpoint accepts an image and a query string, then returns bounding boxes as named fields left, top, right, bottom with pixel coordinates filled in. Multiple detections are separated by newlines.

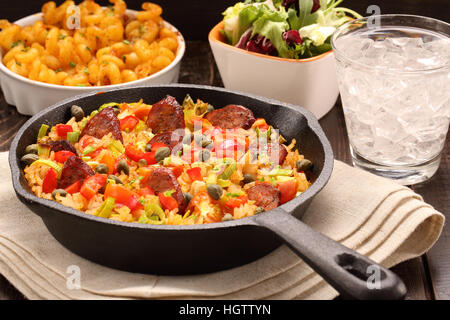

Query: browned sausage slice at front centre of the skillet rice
left=146, top=168, right=186, bottom=215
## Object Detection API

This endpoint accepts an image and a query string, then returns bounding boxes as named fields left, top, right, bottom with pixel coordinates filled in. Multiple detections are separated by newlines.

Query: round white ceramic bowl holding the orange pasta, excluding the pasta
left=0, top=10, right=186, bottom=115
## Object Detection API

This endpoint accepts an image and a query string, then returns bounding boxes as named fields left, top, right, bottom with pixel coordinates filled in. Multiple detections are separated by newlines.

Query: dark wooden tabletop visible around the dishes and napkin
left=0, top=41, right=450, bottom=300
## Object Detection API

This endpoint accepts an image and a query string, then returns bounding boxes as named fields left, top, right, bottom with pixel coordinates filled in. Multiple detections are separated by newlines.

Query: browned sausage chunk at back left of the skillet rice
left=80, top=107, right=123, bottom=142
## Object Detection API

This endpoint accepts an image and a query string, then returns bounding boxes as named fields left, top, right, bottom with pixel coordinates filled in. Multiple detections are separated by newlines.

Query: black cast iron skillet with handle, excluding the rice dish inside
left=9, top=85, right=406, bottom=299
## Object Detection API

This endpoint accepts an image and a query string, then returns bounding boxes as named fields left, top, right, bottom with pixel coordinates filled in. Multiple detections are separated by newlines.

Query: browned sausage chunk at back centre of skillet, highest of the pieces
left=147, top=96, right=185, bottom=134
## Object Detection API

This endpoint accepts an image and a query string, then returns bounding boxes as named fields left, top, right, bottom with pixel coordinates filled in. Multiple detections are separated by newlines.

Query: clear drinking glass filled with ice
left=331, top=14, right=450, bottom=185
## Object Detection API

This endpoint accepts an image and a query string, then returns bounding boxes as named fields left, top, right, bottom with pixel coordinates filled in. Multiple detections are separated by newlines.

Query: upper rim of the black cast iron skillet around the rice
left=8, top=84, right=334, bottom=231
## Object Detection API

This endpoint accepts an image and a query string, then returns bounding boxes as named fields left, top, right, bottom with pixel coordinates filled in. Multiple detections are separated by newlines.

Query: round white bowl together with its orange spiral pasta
left=0, top=0, right=185, bottom=115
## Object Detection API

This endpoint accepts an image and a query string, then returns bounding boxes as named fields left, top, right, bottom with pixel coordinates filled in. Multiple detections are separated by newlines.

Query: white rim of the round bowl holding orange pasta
left=0, top=9, right=186, bottom=92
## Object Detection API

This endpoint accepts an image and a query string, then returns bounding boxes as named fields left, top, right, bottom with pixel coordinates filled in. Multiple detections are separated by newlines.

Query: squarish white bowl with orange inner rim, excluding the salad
left=209, top=22, right=339, bottom=119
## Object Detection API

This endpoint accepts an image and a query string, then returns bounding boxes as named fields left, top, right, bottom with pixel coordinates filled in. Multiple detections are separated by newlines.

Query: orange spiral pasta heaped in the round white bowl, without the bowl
left=0, top=0, right=178, bottom=86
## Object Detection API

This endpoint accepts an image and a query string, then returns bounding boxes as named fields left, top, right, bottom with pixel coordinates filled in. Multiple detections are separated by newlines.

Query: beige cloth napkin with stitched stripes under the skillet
left=0, top=153, right=444, bottom=299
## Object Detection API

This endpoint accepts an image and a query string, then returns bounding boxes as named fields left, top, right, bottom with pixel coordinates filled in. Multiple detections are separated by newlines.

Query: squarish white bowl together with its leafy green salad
left=209, top=0, right=361, bottom=118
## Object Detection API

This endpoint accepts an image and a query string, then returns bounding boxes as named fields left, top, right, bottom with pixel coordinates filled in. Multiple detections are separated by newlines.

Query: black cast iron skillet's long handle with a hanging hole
left=255, top=208, right=406, bottom=300
